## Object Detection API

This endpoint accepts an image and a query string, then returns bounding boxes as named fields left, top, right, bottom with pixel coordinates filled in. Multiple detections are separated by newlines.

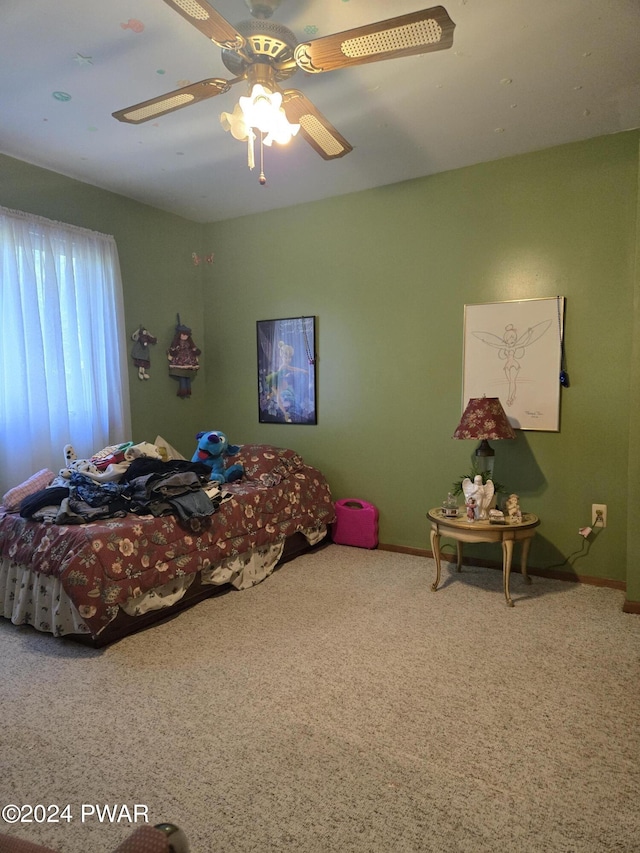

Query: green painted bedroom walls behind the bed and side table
left=0, top=131, right=640, bottom=602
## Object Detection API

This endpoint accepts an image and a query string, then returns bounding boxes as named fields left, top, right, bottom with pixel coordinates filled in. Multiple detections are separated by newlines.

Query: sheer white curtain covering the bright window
left=0, top=207, right=131, bottom=497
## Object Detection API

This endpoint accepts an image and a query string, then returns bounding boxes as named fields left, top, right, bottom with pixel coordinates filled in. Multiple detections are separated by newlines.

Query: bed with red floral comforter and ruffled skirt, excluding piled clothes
left=0, top=444, right=334, bottom=647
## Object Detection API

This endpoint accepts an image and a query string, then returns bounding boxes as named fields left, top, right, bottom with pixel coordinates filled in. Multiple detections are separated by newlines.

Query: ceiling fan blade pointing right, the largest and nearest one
left=296, top=6, right=455, bottom=74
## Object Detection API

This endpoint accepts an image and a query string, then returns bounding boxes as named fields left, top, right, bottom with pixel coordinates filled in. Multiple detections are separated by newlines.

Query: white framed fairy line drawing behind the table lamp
left=462, top=296, right=564, bottom=432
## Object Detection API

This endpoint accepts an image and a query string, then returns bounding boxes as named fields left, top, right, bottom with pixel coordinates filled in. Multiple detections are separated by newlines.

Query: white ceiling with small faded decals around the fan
left=0, top=0, right=640, bottom=222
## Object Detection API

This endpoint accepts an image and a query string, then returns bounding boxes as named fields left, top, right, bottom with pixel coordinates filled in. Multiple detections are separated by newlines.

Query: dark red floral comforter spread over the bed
left=0, top=445, right=334, bottom=635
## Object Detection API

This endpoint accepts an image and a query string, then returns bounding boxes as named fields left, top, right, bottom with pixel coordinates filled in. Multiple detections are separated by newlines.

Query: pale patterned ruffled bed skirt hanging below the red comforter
left=0, top=525, right=327, bottom=637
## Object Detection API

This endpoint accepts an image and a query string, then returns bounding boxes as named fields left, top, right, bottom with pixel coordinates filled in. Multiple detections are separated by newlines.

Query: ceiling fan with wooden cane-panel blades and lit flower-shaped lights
left=113, top=0, right=455, bottom=178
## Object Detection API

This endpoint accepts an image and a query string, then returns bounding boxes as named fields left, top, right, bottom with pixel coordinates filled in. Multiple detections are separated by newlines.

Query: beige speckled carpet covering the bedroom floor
left=0, top=545, right=640, bottom=853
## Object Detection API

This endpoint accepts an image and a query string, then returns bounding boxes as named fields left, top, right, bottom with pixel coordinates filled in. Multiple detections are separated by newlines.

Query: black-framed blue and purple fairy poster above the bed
left=257, top=317, right=317, bottom=424
